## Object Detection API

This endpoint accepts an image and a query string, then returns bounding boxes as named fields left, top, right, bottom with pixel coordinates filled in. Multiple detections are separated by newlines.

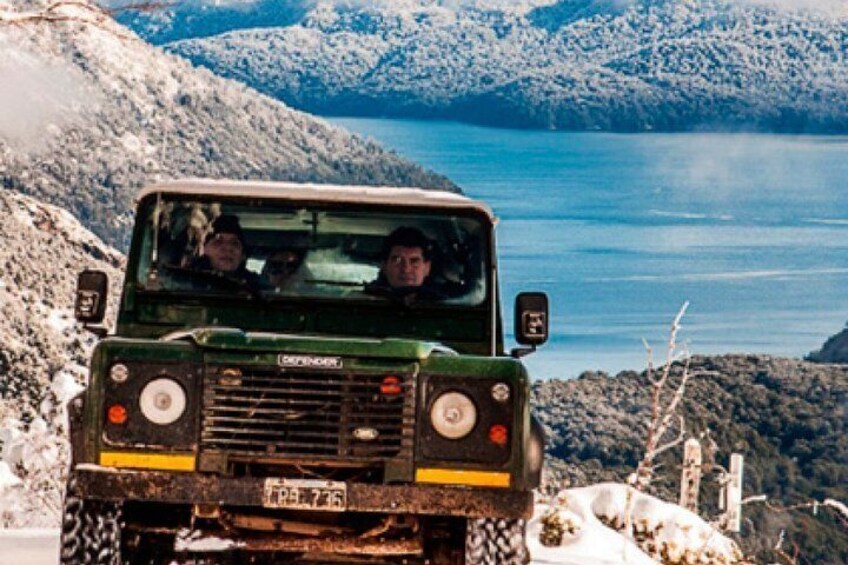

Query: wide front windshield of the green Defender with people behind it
left=136, top=197, right=489, bottom=306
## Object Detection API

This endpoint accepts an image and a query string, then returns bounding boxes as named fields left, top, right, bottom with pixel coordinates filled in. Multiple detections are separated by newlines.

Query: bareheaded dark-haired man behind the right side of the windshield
left=365, top=227, right=444, bottom=301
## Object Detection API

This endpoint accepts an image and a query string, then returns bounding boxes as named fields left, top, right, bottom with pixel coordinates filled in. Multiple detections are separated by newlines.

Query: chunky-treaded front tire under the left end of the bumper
left=59, top=485, right=122, bottom=565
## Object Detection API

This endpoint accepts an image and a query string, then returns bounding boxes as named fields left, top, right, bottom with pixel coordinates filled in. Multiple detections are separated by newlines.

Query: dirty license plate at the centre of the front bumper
left=262, top=478, right=347, bottom=512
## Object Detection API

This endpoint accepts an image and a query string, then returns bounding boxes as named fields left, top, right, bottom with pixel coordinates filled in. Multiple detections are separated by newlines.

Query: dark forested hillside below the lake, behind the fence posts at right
left=534, top=355, right=848, bottom=565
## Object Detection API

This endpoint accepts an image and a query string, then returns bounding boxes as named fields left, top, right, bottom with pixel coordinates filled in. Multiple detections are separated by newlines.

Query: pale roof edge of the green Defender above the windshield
left=136, top=179, right=495, bottom=222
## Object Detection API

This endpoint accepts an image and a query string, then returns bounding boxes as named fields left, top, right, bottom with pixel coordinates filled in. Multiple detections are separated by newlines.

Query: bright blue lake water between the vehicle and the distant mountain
left=333, top=118, right=848, bottom=378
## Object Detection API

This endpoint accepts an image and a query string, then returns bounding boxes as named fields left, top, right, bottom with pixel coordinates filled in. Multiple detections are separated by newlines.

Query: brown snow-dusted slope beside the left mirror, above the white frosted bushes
left=0, top=190, right=124, bottom=416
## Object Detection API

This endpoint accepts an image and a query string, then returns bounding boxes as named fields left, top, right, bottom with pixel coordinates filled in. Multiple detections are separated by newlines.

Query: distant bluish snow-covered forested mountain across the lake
left=168, top=0, right=848, bottom=132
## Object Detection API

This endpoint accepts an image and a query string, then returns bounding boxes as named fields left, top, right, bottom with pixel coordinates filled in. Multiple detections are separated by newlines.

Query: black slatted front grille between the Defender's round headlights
left=201, top=367, right=415, bottom=462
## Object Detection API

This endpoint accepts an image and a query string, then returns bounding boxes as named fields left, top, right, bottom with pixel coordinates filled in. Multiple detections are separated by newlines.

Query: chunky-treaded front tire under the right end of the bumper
left=465, top=518, right=530, bottom=565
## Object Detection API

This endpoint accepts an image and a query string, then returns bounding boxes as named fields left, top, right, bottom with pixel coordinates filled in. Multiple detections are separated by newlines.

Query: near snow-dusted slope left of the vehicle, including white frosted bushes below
left=0, top=190, right=124, bottom=524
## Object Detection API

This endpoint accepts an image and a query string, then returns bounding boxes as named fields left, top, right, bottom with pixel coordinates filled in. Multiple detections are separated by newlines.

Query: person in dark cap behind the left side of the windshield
left=193, top=215, right=259, bottom=285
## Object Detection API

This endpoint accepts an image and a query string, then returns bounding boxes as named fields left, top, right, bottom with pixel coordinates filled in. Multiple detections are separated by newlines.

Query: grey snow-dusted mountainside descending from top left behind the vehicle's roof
left=0, top=0, right=456, bottom=247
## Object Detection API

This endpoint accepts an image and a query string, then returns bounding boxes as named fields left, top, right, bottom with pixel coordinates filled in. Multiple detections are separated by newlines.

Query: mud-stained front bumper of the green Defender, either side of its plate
left=71, top=465, right=533, bottom=518
